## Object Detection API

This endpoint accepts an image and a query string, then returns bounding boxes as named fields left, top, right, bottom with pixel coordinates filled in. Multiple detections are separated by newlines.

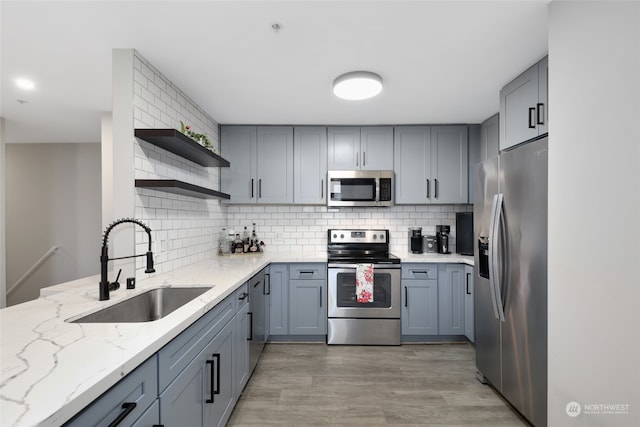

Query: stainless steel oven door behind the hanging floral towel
left=327, top=264, right=401, bottom=319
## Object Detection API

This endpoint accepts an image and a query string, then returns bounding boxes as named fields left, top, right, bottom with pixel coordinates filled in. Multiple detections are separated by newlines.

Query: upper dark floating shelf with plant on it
left=135, top=129, right=230, bottom=168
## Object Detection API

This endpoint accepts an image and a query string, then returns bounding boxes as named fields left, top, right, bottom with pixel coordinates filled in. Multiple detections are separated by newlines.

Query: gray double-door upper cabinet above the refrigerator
left=500, top=57, right=549, bottom=150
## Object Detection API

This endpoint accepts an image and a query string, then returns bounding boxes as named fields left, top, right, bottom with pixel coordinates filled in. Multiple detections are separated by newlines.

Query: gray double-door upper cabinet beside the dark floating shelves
left=220, top=126, right=293, bottom=203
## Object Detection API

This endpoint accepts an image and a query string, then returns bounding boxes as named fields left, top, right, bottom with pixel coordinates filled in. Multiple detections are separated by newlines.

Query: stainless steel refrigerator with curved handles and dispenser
left=474, top=137, right=548, bottom=426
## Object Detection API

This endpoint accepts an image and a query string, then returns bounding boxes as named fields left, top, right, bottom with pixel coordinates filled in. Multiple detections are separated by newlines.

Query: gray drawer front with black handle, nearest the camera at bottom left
left=65, top=355, right=158, bottom=427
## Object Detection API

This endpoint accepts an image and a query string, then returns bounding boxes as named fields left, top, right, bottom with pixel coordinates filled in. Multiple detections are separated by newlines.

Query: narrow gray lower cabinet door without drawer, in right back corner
left=438, top=264, right=466, bottom=335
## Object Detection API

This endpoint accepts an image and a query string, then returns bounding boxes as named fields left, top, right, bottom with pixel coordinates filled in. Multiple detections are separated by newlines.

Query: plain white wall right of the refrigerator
left=548, top=1, right=640, bottom=426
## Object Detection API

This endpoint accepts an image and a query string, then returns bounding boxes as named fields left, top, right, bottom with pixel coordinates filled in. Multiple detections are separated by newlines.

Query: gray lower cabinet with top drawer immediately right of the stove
left=401, top=264, right=438, bottom=335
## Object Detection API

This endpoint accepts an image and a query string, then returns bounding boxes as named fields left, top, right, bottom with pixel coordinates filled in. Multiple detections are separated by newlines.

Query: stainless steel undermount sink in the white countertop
left=70, top=287, right=211, bottom=323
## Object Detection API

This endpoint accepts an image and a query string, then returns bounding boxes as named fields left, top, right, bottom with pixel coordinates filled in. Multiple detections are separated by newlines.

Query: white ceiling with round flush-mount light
left=0, top=0, right=548, bottom=143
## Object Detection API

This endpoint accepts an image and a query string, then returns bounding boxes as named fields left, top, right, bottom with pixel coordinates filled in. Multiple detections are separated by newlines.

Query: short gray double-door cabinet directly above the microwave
left=327, top=126, right=393, bottom=170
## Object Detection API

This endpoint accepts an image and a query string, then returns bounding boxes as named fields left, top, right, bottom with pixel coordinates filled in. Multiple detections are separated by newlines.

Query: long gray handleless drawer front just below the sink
left=158, top=294, right=236, bottom=392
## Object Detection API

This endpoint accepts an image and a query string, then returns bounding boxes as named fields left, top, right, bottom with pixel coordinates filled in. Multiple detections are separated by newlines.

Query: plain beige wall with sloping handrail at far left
left=6, top=143, right=101, bottom=305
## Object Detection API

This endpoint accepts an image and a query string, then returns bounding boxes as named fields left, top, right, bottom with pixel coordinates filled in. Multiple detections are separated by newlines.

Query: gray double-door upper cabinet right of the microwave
left=393, top=126, right=469, bottom=204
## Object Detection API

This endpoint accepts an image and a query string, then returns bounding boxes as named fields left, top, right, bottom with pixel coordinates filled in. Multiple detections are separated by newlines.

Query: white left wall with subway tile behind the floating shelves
left=113, top=49, right=226, bottom=275
